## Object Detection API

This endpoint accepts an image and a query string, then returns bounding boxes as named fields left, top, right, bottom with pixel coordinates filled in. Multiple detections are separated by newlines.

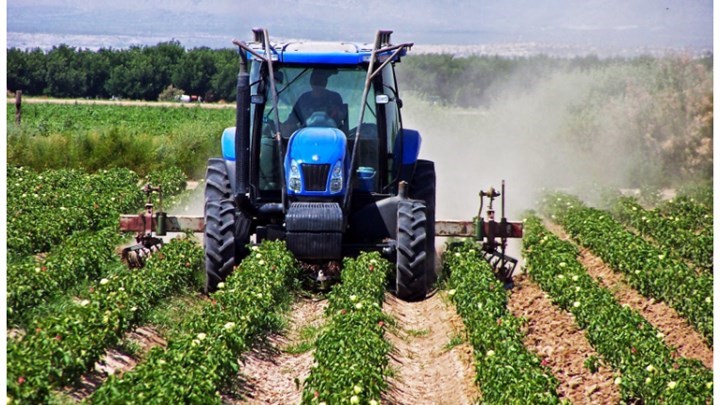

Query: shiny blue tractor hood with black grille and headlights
left=284, top=127, right=347, bottom=197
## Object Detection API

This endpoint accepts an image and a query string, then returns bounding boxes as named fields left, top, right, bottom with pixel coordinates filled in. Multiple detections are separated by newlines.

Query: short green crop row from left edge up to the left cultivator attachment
left=7, top=228, right=120, bottom=325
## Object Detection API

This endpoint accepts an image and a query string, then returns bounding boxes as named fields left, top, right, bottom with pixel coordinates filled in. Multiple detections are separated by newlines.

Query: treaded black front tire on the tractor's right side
left=396, top=200, right=427, bottom=301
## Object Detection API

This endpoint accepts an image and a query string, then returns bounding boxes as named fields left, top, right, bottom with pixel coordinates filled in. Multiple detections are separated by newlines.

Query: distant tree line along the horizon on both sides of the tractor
left=7, top=41, right=712, bottom=107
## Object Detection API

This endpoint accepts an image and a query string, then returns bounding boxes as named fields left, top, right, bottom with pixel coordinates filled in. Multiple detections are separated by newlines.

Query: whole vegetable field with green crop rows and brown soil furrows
left=6, top=99, right=714, bottom=404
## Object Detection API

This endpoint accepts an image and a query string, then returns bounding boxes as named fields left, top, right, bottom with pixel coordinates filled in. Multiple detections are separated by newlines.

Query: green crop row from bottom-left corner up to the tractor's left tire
left=7, top=235, right=202, bottom=403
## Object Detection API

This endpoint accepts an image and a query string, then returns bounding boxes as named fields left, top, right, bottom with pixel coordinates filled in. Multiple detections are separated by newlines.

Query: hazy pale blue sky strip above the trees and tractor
left=7, top=0, right=713, bottom=50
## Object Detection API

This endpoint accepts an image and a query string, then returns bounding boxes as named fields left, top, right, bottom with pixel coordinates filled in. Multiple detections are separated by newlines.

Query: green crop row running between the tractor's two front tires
left=302, top=253, right=391, bottom=404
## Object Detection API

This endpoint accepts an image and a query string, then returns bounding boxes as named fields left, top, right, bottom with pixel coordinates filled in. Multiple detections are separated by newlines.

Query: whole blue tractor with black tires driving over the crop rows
left=204, top=29, right=436, bottom=301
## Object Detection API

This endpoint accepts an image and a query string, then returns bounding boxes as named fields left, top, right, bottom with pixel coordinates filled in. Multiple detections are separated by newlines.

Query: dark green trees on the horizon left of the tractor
left=7, top=41, right=238, bottom=101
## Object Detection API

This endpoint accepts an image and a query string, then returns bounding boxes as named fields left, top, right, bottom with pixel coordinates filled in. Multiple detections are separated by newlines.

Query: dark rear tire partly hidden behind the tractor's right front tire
left=409, top=160, right=438, bottom=290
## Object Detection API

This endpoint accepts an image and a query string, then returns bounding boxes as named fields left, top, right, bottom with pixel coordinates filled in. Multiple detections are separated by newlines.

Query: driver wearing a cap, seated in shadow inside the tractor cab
left=285, top=69, right=345, bottom=132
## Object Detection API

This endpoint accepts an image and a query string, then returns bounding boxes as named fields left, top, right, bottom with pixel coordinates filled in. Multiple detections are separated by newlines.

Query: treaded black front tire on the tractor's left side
left=204, top=200, right=236, bottom=293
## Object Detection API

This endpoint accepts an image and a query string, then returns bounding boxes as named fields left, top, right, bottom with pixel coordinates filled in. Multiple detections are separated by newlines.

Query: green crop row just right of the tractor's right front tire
left=443, top=243, right=560, bottom=404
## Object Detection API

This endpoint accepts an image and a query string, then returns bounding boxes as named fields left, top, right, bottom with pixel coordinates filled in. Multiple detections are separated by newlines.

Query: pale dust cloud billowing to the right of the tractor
left=403, top=66, right=664, bottom=220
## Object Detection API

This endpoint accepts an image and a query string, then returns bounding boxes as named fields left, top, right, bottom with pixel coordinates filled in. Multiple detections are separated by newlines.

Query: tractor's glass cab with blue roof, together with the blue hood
left=239, top=42, right=404, bottom=201
